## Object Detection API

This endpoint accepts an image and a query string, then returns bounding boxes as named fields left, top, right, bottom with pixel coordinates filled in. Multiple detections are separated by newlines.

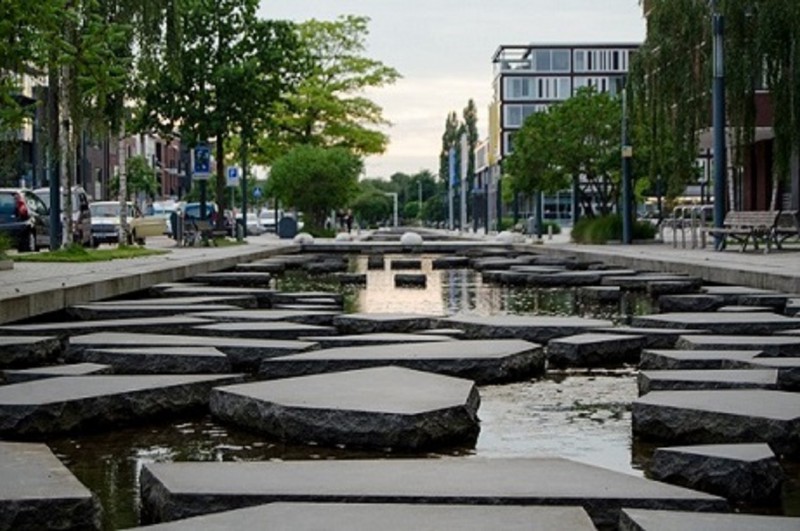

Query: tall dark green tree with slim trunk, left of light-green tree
left=139, top=0, right=297, bottom=229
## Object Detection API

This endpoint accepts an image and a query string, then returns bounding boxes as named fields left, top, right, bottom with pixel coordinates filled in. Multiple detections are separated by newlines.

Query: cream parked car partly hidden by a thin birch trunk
left=89, top=201, right=166, bottom=247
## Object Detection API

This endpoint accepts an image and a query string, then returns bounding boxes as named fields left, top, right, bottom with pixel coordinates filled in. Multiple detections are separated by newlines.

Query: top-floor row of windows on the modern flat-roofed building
left=500, top=48, right=633, bottom=73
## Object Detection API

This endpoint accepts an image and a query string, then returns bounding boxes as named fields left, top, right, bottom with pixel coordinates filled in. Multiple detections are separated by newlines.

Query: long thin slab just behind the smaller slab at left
left=68, top=332, right=319, bottom=372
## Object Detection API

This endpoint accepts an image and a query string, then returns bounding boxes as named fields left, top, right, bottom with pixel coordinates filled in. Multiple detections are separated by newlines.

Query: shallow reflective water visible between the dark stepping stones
left=42, top=256, right=780, bottom=529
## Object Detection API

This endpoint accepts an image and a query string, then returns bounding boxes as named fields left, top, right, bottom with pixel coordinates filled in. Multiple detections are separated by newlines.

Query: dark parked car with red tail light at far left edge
left=0, top=188, right=50, bottom=252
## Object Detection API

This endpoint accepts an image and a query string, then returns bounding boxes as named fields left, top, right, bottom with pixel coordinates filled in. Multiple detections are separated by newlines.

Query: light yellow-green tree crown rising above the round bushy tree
left=260, top=16, right=400, bottom=162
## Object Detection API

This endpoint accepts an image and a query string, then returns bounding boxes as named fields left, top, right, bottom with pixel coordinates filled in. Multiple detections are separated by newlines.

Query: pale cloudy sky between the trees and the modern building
left=259, top=0, right=645, bottom=179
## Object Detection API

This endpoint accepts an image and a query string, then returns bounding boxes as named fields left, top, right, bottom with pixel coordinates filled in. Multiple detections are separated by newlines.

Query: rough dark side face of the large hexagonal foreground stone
left=210, top=385, right=480, bottom=451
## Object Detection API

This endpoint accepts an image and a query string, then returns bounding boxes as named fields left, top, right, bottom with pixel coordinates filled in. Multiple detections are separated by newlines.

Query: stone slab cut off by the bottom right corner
left=619, top=509, right=798, bottom=531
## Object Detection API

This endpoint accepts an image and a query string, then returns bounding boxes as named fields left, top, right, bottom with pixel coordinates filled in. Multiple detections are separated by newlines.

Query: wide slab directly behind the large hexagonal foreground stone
left=260, top=339, right=545, bottom=384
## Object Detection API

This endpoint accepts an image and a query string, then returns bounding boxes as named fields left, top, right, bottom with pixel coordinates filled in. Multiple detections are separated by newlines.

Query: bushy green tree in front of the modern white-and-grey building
left=506, top=89, right=622, bottom=215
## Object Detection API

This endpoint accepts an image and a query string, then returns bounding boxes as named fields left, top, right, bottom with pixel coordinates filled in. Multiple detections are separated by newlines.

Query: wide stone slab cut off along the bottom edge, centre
left=133, top=503, right=596, bottom=531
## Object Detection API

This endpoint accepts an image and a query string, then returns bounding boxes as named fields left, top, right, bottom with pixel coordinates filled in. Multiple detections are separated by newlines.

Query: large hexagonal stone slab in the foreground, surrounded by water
left=210, top=367, right=480, bottom=451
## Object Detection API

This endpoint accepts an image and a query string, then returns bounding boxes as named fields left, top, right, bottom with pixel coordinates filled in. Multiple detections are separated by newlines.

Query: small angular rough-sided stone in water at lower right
left=649, top=443, right=784, bottom=502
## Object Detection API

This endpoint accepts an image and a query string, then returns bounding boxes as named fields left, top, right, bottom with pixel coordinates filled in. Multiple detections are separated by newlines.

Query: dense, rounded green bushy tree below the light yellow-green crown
left=267, top=146, right=363, bottom=228
